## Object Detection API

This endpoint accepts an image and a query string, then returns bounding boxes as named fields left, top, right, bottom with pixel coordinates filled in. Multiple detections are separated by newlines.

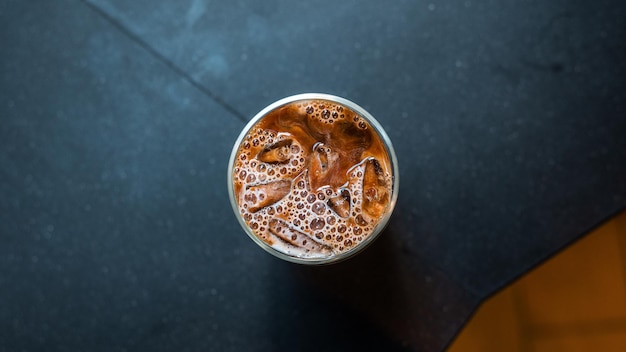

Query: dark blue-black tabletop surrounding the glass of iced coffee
left=0, top=0, right=626, bottom=351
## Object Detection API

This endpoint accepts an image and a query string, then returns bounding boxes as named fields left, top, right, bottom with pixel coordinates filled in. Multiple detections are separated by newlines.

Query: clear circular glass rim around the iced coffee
left=227, top=93, right=400, bottom=265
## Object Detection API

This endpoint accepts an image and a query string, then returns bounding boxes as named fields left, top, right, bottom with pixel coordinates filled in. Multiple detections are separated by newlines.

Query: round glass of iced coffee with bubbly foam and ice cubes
left=228, top=93, right=398, bottom=264
